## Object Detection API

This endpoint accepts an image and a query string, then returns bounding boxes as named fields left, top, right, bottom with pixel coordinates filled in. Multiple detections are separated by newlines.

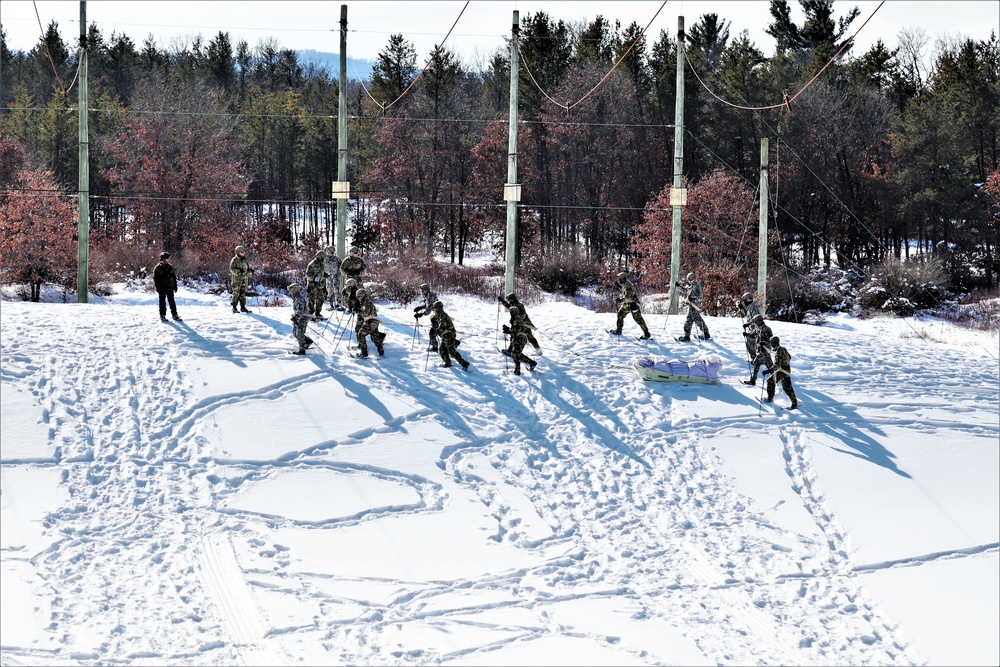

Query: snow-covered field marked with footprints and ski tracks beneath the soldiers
left=0, top=289, right=1000, bottom=665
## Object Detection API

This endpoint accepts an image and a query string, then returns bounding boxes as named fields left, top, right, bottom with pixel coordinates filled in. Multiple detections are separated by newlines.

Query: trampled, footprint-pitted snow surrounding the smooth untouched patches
left=2, top=306, right=996, bottom=664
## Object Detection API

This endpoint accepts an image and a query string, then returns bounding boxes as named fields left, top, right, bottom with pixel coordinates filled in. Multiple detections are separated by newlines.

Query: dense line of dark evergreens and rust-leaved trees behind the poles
left=0, top=0, right=1000, bottom=300
